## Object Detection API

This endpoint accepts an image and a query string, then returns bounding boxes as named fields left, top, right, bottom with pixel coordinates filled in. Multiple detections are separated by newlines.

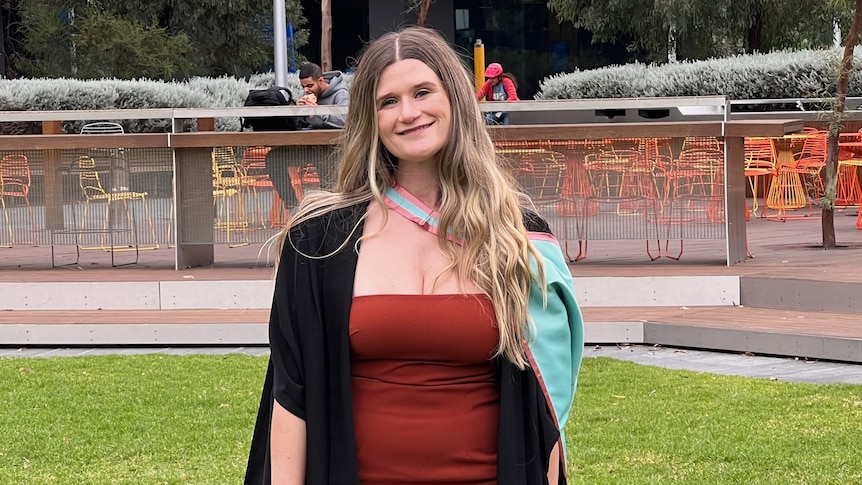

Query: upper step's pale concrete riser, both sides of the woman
left=0, top=275, right=862, bottom=314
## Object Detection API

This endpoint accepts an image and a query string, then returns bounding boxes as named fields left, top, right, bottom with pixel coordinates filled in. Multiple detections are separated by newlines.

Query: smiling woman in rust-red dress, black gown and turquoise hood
left=246, top=27, right=583, bottom=485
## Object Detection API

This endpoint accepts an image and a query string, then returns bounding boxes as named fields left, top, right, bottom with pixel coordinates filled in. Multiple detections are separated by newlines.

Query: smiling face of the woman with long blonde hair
left=376, top=59, right=452, bottom=166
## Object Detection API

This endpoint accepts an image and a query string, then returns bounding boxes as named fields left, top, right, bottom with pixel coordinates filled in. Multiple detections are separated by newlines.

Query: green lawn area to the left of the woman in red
left=0, top=354, right=266, bottom=485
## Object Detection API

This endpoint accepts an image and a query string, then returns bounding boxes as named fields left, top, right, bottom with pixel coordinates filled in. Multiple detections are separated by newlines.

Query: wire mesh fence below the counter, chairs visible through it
left=0, top=138, right=726, bottom=264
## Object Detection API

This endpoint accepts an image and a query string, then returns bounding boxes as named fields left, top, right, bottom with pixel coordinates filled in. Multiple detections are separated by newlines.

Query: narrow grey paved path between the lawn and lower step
left=0, top=345, right=862, bottom=385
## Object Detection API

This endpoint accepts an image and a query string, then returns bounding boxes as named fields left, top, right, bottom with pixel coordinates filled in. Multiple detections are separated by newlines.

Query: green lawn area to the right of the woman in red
left=566, top=358, right=862, bottom=485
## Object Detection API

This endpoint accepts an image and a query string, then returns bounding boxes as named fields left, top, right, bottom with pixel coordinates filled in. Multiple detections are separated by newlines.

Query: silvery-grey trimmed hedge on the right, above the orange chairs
left=536, top=50, right=862, bottom=99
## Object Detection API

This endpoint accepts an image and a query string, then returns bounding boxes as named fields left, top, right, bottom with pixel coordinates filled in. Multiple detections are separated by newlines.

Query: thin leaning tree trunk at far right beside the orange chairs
left=820, top=0, right=862, bottom=249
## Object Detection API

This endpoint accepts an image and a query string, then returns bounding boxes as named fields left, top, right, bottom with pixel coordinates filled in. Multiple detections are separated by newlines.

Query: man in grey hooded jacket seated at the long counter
left=265, top=62, right=350, bottom=210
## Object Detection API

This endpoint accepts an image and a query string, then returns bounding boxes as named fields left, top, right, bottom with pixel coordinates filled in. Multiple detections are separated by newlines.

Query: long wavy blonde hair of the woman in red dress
left=275, top=27, right=545, bottom=368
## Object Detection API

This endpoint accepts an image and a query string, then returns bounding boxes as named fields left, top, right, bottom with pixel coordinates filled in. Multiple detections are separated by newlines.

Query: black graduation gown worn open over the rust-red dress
left=245, top=204, right=565, bottom=485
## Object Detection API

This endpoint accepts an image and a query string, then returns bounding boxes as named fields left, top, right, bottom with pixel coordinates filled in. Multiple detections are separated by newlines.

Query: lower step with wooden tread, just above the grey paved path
left=0, top=305, right=862, bottom=362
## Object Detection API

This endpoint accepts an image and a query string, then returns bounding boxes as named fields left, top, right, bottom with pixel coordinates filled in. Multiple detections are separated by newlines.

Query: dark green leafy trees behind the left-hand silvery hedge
left=14, top=0, right=308, bottom=79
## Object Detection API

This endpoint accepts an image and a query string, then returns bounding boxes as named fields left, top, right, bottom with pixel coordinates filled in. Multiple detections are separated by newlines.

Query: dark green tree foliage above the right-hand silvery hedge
left=548, top=0, right=848, bottom=62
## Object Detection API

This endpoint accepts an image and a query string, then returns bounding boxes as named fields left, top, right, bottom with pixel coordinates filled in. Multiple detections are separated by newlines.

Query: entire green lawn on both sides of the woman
left=0, top=354, right=862, bottom=485
